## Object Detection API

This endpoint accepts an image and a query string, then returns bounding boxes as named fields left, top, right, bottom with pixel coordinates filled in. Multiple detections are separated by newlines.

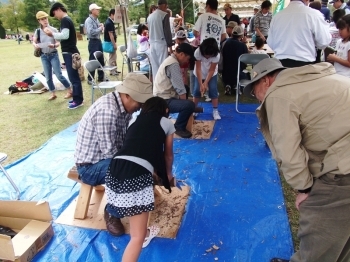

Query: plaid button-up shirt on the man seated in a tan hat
left=74, top=92, right=131, bottom=164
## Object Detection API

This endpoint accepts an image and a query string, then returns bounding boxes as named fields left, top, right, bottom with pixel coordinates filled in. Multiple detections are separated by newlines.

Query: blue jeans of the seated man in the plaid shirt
left=77, top=158, right=112, bottom=186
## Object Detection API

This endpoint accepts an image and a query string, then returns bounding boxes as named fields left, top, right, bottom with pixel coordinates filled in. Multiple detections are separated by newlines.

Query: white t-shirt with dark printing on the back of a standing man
left=193, top=13, right=226, bottom=46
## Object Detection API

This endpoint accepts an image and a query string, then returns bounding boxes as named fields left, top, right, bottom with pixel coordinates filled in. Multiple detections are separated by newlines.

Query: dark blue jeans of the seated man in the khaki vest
left=166, top=98, right=195, bottom=130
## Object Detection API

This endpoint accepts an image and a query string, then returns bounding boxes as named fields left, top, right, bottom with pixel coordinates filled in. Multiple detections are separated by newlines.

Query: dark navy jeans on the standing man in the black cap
left=62, top=52, right=84, bottom=104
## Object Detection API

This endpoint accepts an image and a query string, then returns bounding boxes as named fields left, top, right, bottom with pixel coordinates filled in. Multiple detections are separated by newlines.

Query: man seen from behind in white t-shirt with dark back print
left=193, top=0, right=226, bottom=47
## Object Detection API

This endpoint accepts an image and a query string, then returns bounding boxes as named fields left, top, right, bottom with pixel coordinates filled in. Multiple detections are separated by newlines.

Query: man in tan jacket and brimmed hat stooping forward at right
left=244, top=58, right=350, bottom=262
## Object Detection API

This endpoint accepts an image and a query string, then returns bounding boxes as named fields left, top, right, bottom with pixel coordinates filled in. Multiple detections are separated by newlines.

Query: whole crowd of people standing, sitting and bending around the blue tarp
left=28, top=0, right=350, bottom=262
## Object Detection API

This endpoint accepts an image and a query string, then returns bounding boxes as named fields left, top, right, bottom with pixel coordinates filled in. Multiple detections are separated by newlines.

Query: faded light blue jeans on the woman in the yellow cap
left=41, top=52, right=70, bottom=92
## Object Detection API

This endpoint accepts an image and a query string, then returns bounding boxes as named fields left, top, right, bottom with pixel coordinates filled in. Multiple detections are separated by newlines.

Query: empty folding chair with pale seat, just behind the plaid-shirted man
left=84, top=60, right=123, bottom=104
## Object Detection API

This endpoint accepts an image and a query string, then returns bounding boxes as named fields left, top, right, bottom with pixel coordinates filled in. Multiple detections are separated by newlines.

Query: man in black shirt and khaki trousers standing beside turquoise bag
left=104, top=8, right=119, bottom=76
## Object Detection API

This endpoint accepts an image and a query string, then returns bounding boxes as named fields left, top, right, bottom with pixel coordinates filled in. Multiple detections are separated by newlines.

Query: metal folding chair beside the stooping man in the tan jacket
left=236, top=54, right=269, bottom=114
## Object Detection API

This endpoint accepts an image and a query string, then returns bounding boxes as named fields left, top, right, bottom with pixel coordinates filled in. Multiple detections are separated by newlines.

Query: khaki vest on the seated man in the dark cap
left=153, top=56, right=179, bottom=99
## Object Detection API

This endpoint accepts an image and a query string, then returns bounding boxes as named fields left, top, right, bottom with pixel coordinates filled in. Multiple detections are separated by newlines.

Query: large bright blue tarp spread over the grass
left=0, top=103, right=293, bottom=262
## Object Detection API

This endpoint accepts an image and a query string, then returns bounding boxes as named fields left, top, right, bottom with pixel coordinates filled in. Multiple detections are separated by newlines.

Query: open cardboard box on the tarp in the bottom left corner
left=0, top=201, right=53, bottom=262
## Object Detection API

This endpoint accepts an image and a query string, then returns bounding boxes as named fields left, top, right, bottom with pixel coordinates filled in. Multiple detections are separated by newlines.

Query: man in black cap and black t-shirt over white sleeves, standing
left=44, top=2, right=84, bottom=109
